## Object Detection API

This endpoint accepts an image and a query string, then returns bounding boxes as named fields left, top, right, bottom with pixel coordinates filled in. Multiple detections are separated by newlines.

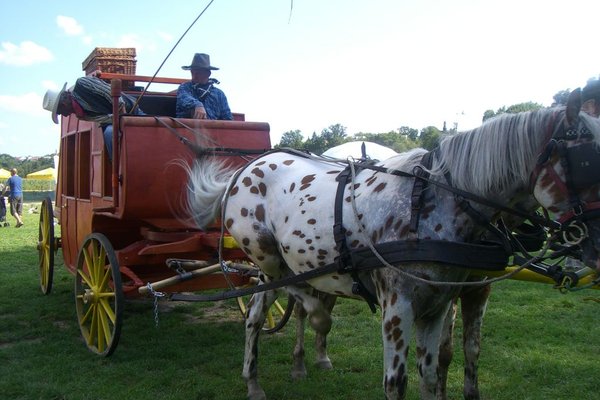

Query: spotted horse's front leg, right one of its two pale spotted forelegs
left=415, top=301, right=451, bottom=400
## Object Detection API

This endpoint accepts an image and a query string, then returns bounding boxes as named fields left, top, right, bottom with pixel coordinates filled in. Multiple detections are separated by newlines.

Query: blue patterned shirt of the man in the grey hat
left=175, top=82, right=233, bottom=120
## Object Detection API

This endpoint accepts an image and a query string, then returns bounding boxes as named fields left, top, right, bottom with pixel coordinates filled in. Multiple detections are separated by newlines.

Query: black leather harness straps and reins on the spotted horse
left=170, top=119, right=600, bottom=309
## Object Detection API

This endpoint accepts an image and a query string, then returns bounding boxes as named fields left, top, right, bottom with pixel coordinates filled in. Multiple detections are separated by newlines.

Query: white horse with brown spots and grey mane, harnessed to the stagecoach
left=189, top=93, right=600, bottom=399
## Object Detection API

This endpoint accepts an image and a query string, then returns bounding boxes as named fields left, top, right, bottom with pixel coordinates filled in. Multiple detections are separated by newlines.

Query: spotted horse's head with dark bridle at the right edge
left=533, top=89, right=600, bottom=271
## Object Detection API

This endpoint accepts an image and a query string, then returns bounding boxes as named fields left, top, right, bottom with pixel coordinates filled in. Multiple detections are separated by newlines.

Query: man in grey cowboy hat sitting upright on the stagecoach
left=176, top=53, right=233, bottom=120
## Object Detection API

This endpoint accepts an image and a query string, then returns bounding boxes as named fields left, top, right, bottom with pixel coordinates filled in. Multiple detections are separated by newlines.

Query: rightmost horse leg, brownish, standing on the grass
left=460, top=285, right=491, bottom=400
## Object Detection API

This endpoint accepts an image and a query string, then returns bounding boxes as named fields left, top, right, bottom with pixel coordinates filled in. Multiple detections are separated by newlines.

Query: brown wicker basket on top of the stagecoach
left=81, top=47, right=136, bottom=75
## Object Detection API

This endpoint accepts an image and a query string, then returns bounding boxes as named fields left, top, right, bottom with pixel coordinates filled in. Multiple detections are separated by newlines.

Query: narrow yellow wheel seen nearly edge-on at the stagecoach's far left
left=37, top=197, right=55, bottom=294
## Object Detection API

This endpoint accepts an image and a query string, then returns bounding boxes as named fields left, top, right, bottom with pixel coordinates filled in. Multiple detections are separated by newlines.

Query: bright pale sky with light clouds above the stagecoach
left=0, top=0, right=600, bottom=157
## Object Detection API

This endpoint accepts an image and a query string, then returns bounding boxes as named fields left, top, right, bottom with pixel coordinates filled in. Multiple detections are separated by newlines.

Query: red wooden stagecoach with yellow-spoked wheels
left=38, top=49, right=292, bottom=356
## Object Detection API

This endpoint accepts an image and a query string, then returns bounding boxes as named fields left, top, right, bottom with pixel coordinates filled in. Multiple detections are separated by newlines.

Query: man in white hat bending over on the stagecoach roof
left=42, top=76, right=144, bottom=158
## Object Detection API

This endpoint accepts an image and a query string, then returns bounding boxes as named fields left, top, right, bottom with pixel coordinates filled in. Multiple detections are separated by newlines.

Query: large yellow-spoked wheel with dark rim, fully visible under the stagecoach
left=75, top=233, right=123, bottom=357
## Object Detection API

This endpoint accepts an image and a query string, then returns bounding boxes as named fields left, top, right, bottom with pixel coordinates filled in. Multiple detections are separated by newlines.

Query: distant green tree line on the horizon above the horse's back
left=275, top=89, right=571, bottom=154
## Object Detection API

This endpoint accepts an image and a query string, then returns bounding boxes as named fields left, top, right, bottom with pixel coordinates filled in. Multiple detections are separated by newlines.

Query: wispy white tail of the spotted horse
left=187, top=159, right=235, bottom=229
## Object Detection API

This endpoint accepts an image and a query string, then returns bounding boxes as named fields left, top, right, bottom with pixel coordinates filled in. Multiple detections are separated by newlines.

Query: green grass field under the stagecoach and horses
left=0, top=206, right=600, bottom=400
